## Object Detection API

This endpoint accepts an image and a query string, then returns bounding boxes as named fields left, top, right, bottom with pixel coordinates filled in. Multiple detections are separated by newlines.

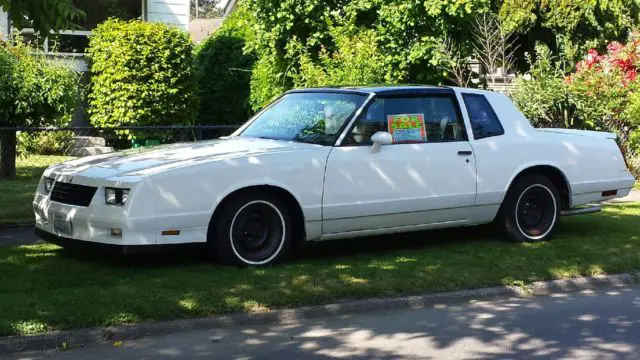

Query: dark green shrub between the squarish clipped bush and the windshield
left=195, top=7, right=255, bottom=124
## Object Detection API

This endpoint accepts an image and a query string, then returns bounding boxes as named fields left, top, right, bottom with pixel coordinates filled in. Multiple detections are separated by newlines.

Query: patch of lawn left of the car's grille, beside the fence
left=0, top=155, right=69, bottom=224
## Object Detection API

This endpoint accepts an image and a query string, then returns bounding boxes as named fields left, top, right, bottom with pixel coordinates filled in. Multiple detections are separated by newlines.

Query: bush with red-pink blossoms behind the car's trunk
left=512, top=31, right=640, bottom=174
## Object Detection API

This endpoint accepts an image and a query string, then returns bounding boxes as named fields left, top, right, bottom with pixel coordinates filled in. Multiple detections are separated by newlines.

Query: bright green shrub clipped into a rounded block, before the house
left=87, top=19, right=197, bottom=136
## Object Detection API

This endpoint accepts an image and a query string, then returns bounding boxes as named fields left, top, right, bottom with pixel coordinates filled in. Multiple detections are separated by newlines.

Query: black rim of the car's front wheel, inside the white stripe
left=231, top=201, right=285, bottom=264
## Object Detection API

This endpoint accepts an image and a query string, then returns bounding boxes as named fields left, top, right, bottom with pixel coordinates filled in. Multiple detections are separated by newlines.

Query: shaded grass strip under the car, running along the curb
left=0, top=203, right=640, bottom=335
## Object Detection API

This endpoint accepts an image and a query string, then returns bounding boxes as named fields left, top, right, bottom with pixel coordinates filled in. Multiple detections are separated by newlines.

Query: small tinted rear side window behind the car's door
left=462, top=94, right=504, bottom=140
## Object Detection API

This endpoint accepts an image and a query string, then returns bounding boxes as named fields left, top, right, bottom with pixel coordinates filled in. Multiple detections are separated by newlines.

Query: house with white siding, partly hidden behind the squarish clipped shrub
left=0, top=0, right=190, bottom=67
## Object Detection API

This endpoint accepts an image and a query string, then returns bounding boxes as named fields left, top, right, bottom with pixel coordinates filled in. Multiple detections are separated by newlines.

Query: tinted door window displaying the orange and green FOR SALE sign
left=344, top=96, right=466, bottom=145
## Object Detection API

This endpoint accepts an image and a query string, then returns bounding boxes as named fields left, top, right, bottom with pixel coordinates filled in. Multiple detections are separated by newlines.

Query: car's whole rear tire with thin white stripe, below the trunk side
left=496, top=175, right=560, bottom=242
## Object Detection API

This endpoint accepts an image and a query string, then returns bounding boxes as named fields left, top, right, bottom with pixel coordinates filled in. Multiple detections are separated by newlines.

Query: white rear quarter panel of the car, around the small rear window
left=461, top=90, right=624, bottom=210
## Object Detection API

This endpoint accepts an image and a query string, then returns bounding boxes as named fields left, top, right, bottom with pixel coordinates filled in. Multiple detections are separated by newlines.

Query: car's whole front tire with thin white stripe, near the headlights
left=207, top=192, right=293, bottom=267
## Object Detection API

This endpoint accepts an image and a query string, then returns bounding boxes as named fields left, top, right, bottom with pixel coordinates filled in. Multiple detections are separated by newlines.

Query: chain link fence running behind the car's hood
left=0, top=125, right=238, bottom=177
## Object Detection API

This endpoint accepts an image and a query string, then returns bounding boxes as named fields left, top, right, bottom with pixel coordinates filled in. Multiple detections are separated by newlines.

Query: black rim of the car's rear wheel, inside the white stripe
left=516, top=185, right=556, bottom=238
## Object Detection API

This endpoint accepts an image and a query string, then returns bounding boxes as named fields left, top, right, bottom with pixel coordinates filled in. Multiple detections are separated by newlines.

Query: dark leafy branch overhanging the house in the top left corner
left=0, top=0, right=85, bottom=34
